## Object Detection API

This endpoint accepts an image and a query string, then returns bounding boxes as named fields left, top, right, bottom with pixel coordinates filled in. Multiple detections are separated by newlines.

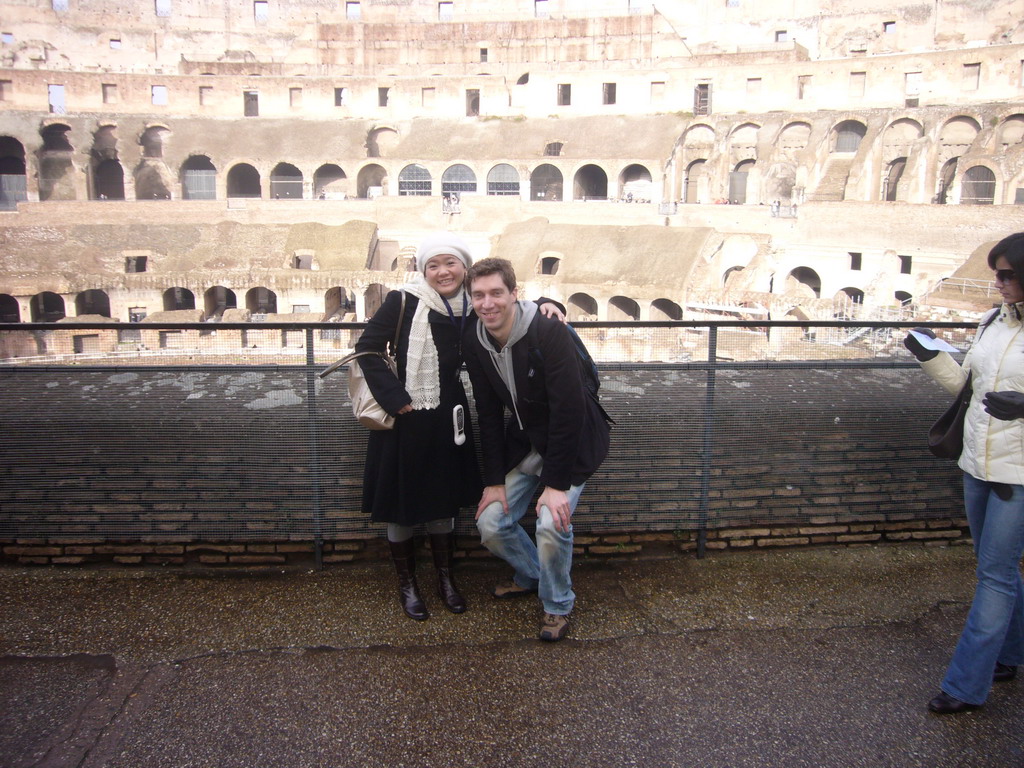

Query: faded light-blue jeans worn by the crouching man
left=476, top=460, right=583, bottom=615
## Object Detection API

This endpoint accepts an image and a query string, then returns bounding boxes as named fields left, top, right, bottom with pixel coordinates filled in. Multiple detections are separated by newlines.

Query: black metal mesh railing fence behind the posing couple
left=0, top=322, right=973, bottom=543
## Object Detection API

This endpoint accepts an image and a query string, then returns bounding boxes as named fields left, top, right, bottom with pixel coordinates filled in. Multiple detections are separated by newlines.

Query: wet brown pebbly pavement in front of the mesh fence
left=0, top=547, right=1024, bottom=768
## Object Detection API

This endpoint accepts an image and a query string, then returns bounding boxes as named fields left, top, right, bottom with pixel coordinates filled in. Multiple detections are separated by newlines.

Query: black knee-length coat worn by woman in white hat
left=355, top=291, right=482, bottom=525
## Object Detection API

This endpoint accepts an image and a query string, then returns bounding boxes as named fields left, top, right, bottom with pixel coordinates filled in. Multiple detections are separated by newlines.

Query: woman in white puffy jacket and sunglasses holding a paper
left=904, top=232, right=1024, bottom=715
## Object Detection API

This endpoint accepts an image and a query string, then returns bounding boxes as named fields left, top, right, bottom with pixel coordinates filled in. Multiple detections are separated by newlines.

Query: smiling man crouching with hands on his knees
left=463, top=258, right=609, bottom=641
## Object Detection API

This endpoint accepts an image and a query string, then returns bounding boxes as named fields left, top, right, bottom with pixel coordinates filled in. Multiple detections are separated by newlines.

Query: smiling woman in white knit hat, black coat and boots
left=355, top=232, right=565, bottom=621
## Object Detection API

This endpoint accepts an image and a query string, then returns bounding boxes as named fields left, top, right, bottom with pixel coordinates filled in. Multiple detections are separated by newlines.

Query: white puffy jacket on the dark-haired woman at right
left=921, top=302, right=1024, bottom=485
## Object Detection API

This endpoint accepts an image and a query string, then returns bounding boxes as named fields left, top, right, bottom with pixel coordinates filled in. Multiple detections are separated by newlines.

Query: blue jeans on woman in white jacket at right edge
left=942, top=474, right=1024, bottom=705
